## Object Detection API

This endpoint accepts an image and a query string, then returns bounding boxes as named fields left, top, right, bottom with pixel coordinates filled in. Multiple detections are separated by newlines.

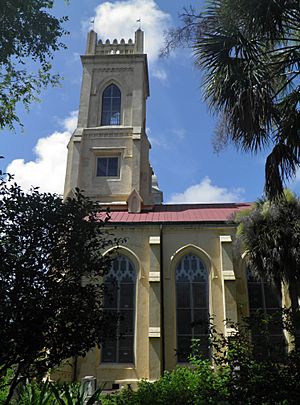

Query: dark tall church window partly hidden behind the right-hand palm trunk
left=247, top=268, right=286, bottom=357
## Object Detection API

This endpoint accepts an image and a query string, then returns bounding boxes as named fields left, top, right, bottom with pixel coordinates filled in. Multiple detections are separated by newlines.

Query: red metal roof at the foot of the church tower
left=99, top=203, right=251, bottom=224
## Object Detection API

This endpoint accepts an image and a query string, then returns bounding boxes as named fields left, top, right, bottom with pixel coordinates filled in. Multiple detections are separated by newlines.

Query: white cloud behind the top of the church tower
left=89, top=0, right=171, bottom=80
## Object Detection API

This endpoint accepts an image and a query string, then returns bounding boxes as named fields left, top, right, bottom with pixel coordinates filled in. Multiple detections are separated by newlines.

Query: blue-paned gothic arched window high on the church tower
left=101, top=84, right=121, bottom=125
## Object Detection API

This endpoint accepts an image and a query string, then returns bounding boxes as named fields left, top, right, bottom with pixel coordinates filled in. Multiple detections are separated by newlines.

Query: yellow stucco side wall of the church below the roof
left=56, top=224, right=247, bottom=388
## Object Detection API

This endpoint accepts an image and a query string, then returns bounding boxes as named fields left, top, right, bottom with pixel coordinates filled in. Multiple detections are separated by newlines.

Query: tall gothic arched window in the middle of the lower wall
left=176, top=254, right=209, bottom=362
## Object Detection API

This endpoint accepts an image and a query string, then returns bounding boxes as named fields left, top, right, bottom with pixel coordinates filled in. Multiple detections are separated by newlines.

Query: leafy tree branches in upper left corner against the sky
left=0, top=0, right=67, bottom=129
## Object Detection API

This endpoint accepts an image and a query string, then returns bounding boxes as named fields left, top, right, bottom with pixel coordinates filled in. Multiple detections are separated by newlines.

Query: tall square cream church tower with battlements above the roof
left=64, top=29, right=162, bottom=212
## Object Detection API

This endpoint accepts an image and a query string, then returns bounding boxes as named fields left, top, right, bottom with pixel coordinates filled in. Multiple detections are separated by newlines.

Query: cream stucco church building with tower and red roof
left=58, top=29, right=281, bottom=388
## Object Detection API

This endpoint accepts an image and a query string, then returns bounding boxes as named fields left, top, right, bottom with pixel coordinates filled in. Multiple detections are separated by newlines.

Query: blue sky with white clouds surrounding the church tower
left=0, top=0, right=300, bottom=202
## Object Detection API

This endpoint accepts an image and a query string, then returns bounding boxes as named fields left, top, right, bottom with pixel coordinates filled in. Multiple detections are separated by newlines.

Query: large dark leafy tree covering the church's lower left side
left=0, top=181, right=117, bottom=404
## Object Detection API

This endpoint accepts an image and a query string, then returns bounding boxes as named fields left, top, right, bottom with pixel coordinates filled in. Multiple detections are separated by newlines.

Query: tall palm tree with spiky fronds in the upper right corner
left=165, top=0, right=300, bottom=198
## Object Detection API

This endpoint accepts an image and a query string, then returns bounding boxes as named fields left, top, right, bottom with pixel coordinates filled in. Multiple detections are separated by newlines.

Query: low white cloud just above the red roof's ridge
left=168, top=177, right=244, bottom=204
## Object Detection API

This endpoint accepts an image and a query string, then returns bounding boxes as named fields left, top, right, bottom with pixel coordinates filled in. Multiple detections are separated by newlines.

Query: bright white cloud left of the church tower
left=6, top=111, right=78, bottom=194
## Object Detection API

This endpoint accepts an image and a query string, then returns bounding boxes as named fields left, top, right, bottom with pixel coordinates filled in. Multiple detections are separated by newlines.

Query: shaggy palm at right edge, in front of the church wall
left=236, top=190, right=300, bottom=348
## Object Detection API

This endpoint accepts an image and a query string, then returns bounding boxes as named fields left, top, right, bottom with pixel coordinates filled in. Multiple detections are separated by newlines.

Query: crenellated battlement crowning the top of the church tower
left=86, top=29, right=144, bottom=55
